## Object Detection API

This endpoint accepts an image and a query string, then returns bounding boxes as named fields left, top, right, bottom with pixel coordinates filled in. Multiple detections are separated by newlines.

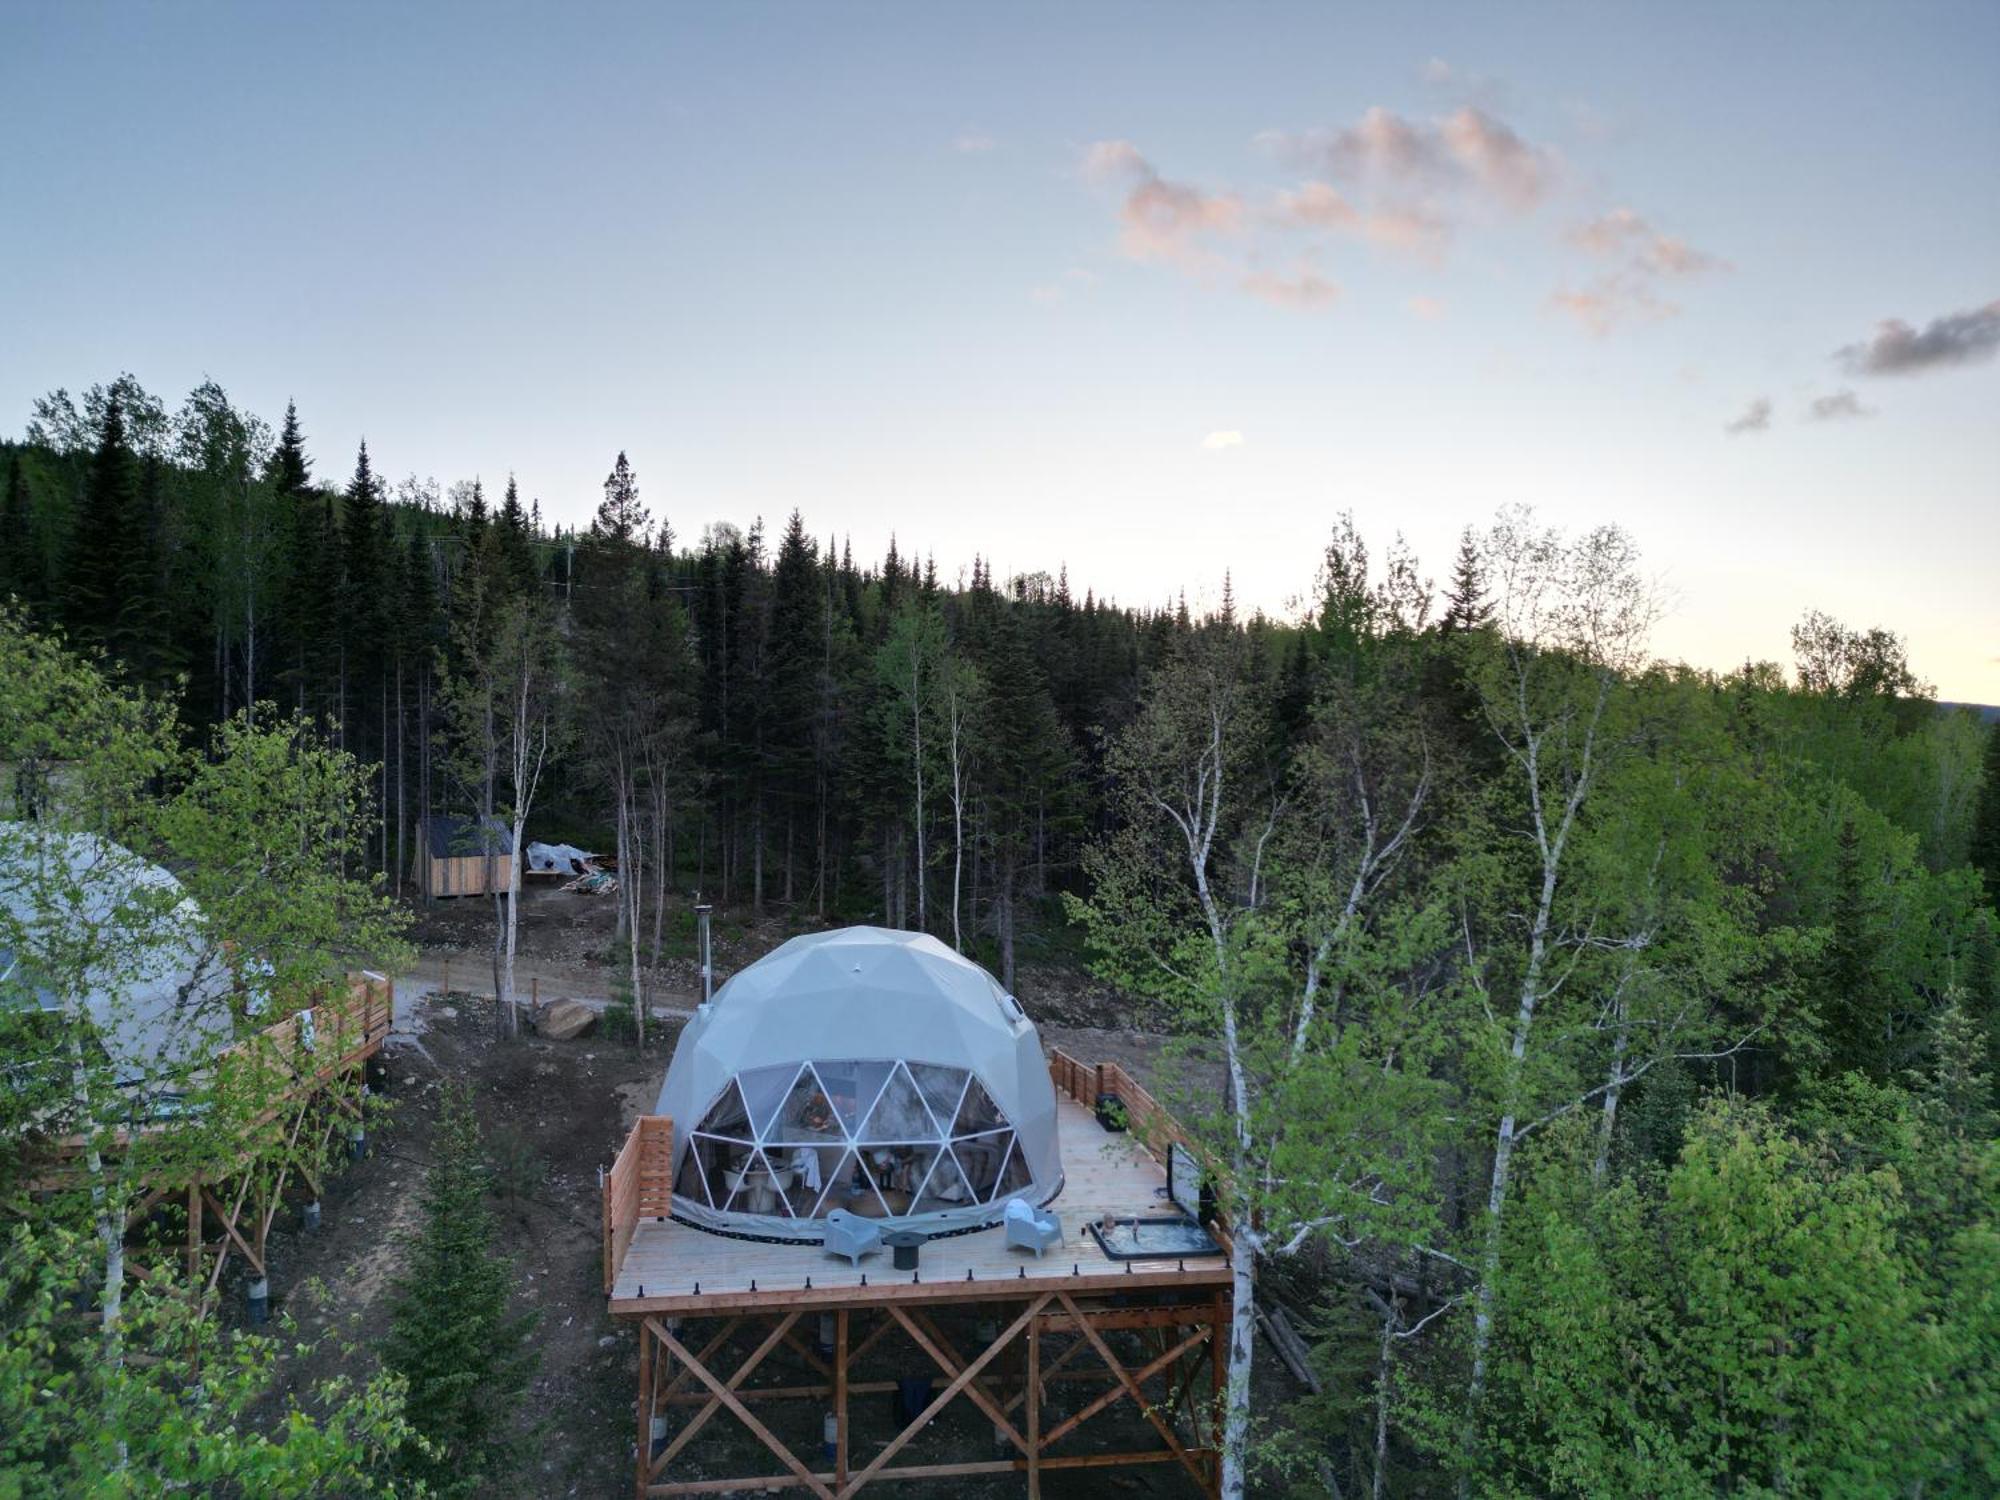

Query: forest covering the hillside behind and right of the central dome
left=0, top=376, right=2000, bottom=1496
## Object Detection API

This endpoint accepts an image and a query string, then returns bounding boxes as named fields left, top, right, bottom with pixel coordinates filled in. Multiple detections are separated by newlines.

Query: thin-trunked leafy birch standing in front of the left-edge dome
left=0, top=618, right=400, bottom=1360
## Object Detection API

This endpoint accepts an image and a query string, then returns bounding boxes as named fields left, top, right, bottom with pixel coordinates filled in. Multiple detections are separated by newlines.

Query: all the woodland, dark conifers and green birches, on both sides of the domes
left=0, top=376, right=2000, bottom=1500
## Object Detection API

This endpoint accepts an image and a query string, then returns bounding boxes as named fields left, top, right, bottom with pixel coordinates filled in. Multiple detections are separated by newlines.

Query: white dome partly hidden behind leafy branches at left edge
left=0, top=822, right=232, bottom=1082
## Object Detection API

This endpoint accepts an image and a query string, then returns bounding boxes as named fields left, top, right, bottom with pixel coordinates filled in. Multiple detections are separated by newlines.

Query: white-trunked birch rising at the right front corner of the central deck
left=1072, top=622, right=1442, bottom=1500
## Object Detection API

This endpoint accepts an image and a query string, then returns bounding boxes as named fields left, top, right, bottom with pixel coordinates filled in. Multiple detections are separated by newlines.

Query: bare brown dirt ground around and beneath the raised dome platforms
left=270, top=892, right=1282, bottom=1500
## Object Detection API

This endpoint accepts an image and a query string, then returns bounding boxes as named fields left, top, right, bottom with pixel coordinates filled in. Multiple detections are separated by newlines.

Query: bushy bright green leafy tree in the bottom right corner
left=1440, top=1100, right=1996, bottom=1500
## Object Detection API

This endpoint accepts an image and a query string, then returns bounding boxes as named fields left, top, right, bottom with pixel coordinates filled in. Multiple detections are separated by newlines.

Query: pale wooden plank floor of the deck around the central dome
left=610, top=1092, right=1228, bottom=1316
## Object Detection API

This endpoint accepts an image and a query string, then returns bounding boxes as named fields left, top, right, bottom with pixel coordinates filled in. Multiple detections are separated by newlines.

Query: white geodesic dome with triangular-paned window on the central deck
left=658, top=928, right=1062, bottom=1240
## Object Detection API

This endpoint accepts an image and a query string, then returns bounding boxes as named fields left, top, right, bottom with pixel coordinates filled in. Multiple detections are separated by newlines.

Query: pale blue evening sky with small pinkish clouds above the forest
left=0, top=0, right=2000, bottom=702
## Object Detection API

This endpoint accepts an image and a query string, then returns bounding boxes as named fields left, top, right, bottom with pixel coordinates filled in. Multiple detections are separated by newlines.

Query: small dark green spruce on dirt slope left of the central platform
left=382, top=1084, right=540, bottom=1494
